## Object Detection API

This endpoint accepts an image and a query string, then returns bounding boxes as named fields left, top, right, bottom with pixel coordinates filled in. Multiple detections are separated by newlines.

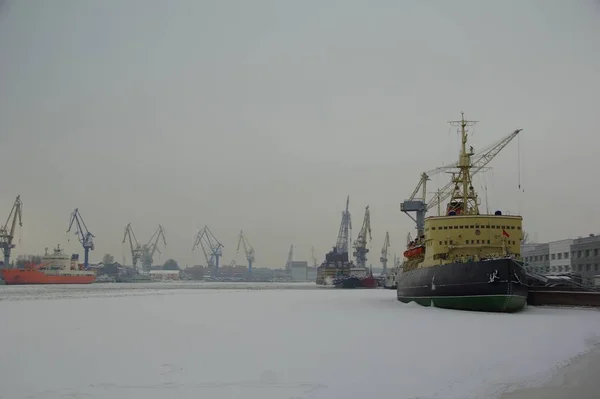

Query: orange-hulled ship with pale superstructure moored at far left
left=2, top=246, right=96, bottom=285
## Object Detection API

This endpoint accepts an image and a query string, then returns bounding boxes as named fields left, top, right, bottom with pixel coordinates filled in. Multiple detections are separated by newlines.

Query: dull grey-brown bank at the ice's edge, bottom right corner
left=500, top=346, right=600, bottom=399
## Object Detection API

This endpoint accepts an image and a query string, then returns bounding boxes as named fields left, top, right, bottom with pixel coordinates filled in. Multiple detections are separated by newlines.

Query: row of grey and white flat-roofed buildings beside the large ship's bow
left=521, top=234, right=600, bottom=285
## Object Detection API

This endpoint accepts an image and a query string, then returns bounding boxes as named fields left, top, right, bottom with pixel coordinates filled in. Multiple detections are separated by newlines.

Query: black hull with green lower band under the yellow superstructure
left=397, top=258, right=528, bottom=312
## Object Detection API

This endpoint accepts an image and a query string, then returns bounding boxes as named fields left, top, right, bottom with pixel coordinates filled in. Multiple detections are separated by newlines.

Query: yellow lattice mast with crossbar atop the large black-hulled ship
left=448, top=112, right=479, bottom=215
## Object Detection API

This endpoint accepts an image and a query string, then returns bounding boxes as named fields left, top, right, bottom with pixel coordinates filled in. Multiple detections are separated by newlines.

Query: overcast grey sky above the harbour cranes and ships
left=0, top=0, right=600, bottom=267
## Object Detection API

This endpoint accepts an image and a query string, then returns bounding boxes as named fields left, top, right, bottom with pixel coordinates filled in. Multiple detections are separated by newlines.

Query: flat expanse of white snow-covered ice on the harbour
left=0, top=284, right=600, bottom=399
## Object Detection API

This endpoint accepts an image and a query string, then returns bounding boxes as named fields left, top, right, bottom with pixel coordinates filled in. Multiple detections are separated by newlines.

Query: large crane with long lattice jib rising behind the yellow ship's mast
left=400, top=129, right=523, bottom=238
